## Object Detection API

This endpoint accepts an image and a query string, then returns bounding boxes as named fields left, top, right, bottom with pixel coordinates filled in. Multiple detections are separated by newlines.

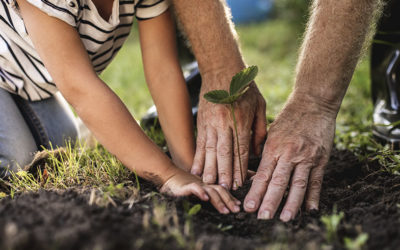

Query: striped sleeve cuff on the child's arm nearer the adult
left=135, top=0, right=170, bottom=20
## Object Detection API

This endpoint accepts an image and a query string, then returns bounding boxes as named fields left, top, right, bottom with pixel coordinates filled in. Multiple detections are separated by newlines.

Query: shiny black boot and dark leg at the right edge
left=371, top=0, right=400, bottom=146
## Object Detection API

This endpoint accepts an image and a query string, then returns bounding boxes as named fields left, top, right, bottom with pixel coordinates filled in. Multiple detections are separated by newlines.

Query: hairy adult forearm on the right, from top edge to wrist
left=291, top=0, right=380, bottom=115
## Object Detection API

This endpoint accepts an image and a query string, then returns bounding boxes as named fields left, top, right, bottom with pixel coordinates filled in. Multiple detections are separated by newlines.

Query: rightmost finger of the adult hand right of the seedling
left=306, top=162, right=326, bottom=210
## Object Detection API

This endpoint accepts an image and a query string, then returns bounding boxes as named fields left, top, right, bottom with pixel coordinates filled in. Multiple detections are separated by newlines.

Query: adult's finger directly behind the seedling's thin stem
left=232, top=132, right=250, bottom=190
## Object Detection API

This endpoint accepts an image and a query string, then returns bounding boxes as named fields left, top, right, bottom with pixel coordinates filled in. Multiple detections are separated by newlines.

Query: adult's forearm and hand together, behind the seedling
left=172, top=0, right=266, bottom=189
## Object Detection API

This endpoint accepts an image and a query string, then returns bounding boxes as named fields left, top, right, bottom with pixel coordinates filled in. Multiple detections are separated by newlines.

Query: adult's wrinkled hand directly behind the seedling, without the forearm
left=191, top=76, right=266, bottom=189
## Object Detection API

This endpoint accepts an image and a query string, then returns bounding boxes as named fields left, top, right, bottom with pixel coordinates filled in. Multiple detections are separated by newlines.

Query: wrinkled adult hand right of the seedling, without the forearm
left=244, top=95, right=336, bottom=221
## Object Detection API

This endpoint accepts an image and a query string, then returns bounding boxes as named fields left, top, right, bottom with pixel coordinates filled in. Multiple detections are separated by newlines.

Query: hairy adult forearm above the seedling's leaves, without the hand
left=172, top=0, right=245, bottom=85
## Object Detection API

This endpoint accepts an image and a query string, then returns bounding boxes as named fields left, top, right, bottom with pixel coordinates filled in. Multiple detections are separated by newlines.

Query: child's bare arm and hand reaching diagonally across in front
left=18, top=0, right=239, bottom=213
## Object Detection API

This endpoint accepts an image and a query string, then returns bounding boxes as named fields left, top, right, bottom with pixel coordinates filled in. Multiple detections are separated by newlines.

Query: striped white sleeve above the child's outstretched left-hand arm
left=23, top=0, right=82, bottom=27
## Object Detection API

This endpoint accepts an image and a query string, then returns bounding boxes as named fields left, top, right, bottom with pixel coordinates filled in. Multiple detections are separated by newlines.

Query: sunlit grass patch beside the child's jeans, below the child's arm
left=5, top=144, right=139, bottom=194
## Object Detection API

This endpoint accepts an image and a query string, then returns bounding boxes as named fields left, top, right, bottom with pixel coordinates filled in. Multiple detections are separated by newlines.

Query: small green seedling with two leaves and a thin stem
left=204, top=66, right=258, bottom=182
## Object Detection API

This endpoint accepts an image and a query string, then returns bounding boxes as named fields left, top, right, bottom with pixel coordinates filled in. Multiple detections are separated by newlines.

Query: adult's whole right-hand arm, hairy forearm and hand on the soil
left=244, top=0, right=381, bottom=221
